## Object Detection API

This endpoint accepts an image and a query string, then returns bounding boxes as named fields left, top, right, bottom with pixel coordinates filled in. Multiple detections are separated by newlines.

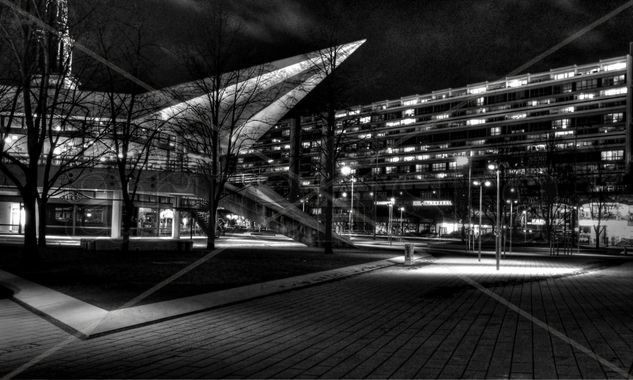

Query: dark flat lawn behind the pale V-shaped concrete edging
left=0, top=246, right=395, bottom=310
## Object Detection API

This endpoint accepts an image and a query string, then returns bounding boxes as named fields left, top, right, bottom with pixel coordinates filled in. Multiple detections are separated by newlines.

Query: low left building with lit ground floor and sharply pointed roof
left=0, top=0, right=364, bottom=241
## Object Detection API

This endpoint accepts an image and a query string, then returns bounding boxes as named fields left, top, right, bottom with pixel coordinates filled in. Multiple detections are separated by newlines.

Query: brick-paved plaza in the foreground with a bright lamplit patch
left=0, top=251, right=633, bottom=378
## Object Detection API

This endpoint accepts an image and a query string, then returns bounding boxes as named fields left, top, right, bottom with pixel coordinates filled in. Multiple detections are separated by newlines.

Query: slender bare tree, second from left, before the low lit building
left=89, top=3, right=169, bottom=252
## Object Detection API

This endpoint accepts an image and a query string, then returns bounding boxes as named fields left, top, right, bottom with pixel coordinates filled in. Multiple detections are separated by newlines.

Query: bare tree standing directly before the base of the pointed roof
left=173, top=4, right=278, bottom=249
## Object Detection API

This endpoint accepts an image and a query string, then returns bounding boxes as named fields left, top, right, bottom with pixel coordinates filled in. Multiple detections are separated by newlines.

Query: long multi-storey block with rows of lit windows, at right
left=240, top=56, right=631, bottom=245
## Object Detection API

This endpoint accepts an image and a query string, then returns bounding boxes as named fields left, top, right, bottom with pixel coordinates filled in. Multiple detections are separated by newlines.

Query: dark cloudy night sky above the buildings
left=81, top=0, right=633, bottom=104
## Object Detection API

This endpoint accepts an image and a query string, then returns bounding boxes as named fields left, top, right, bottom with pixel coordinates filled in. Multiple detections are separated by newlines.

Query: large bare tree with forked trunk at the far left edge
left=0, top=1, right=98, bottom=259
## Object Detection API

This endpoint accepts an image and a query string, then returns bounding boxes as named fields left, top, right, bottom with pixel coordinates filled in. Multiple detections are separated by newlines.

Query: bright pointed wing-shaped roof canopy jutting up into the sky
left=142, top=40, right=365, bottom=149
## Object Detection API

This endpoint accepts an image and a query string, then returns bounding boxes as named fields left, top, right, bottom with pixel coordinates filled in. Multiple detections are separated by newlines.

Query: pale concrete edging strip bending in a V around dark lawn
left=0, top=249, right=402, bottom=338
